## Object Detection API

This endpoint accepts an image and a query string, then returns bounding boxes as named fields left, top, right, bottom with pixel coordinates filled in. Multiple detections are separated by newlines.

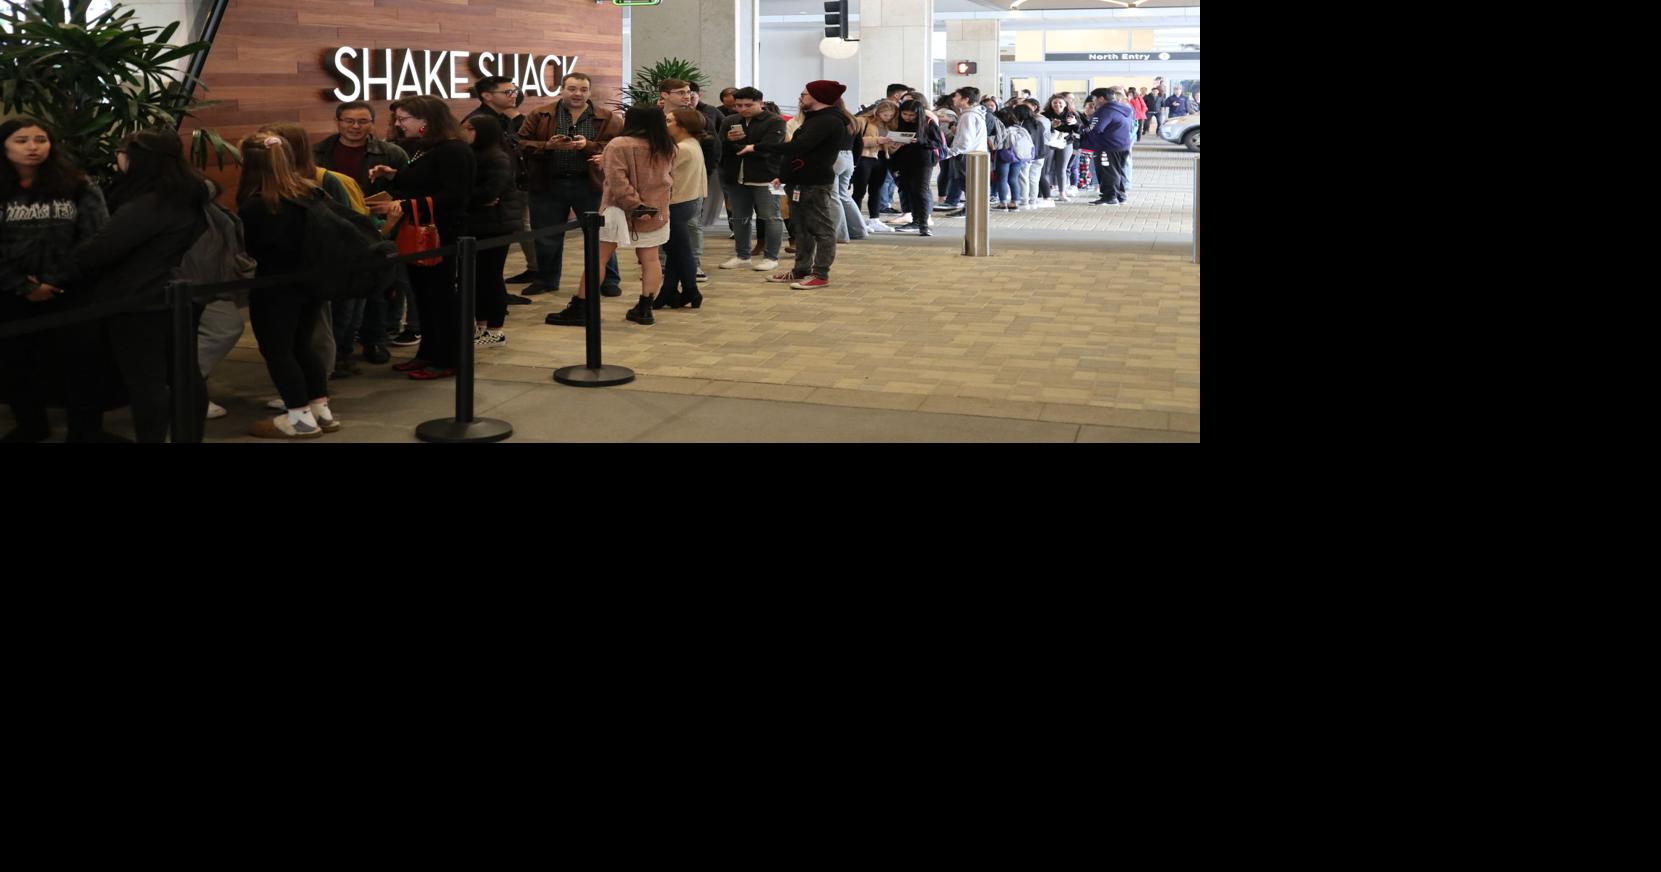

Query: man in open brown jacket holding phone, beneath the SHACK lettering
left=520, top=73, right=623, bottom=298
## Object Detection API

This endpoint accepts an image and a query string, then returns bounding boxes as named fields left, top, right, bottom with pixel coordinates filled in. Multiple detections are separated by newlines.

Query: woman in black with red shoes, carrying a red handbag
left=369, top=95, right=478, bottom=380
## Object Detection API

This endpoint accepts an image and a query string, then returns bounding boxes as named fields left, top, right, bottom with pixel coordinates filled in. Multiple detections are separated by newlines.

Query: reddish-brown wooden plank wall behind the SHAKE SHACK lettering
left=183, top=0, right=623, bottom=198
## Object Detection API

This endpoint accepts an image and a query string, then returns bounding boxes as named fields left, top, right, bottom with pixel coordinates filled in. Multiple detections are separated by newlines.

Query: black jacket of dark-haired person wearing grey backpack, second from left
left=65, top=194, right=208, bottom=309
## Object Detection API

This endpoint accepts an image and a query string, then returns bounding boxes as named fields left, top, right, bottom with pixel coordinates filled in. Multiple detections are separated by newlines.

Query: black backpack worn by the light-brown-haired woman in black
left=291, top=196, right=399, bottom=301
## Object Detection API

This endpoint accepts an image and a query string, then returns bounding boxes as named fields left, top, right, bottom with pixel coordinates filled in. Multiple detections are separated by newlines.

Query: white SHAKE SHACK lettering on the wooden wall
left=327, top=45, right=576, bottom=103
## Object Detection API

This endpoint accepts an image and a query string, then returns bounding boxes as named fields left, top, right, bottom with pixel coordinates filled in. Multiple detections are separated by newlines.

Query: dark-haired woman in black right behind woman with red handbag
left=462, top=113, right=525, bottom=349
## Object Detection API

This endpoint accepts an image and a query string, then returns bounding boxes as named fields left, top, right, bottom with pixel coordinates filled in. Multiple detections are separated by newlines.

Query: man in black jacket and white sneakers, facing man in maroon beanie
left=716, top=88, right=784, bottom=272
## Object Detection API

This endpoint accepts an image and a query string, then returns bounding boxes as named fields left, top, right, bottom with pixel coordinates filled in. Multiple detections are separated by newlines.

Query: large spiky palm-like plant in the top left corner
left=0, top=0, right=241, bottom=179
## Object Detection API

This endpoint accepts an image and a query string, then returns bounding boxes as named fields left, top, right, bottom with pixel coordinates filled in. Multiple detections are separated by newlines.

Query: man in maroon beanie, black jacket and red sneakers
left=739, top=80, right=852, bottom=291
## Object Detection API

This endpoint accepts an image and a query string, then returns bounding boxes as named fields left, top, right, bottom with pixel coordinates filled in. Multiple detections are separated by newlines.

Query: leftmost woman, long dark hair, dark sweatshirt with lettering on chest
left=0, top=118, right=110, bottom=442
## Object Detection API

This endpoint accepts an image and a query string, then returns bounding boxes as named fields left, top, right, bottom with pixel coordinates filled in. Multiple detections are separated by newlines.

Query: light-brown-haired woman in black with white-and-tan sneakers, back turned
left=236, top=131, right=341, bottom=438
